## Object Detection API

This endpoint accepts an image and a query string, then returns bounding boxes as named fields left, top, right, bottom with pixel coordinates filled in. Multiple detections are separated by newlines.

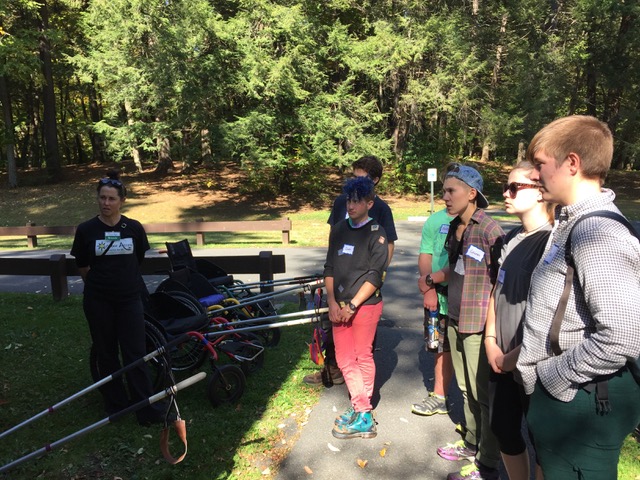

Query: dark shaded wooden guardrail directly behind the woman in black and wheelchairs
left=0, top=251, right=286, bottom=301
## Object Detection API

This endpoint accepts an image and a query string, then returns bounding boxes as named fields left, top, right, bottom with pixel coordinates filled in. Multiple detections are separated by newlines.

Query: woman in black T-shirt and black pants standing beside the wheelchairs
left=71, top=171, right=166, bottom=425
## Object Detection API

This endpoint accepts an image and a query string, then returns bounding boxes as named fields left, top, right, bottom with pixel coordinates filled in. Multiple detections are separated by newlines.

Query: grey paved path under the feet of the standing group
left=277, top=222, right=476, bottom=480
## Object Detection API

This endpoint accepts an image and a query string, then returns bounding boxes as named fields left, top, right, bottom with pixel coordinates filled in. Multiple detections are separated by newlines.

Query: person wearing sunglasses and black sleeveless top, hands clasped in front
left=484, top=161, right=553, bottom=480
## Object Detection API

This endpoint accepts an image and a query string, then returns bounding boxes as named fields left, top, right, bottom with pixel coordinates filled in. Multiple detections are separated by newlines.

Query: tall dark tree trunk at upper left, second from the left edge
left=39, top=1, right=61, bottom=181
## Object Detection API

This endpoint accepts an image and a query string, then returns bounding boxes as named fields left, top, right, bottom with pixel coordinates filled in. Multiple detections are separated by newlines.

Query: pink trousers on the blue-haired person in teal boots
left=333, top=302, right=382, bottom=412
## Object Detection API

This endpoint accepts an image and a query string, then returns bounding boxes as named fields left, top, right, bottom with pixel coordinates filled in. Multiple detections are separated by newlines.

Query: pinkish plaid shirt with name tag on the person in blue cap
left=447, top=209, right=504, bottom=333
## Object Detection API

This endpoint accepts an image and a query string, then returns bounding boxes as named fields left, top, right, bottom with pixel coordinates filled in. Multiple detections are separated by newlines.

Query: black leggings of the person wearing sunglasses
left=489, top=371, right=528, bottom=455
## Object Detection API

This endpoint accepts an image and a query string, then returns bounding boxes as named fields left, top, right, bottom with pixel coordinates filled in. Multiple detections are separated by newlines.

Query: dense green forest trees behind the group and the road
left=0, top=0, right=640, bottom=196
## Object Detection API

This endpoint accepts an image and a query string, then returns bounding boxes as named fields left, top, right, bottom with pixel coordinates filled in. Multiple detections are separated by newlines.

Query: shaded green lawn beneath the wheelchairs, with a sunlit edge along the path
left=0, top=294, right=320, bottom=480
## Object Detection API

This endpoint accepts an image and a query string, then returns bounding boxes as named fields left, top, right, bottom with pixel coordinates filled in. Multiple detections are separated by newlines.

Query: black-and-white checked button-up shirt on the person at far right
left=518, top=189, right=640, bottom=402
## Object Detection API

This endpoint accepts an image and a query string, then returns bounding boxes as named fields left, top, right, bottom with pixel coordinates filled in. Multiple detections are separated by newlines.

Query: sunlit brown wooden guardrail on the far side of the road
left=0, top=218, right=291, bottom=248
